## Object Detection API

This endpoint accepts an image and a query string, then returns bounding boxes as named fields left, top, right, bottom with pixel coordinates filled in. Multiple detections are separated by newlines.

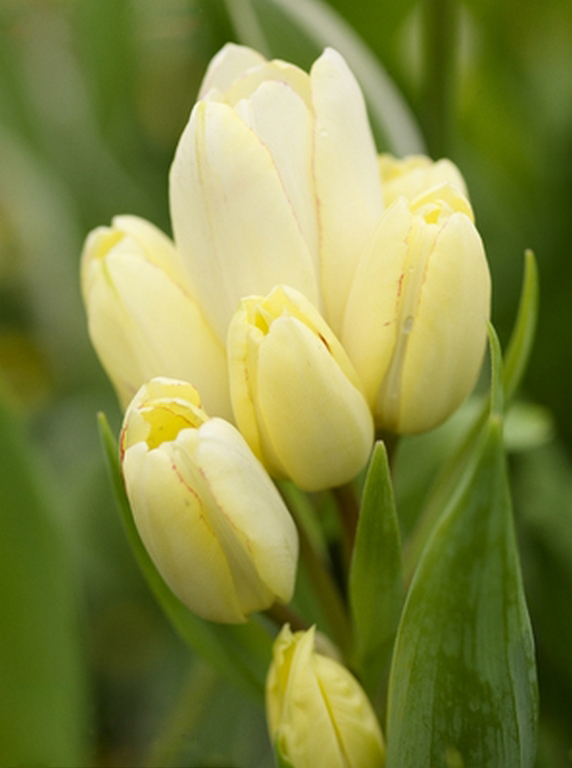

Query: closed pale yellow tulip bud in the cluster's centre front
left=227, top=286, right=373, bottom=491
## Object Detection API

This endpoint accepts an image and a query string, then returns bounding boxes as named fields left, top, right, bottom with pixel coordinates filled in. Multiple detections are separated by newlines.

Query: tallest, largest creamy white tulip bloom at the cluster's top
left=170, top=45, right=382, bottom=340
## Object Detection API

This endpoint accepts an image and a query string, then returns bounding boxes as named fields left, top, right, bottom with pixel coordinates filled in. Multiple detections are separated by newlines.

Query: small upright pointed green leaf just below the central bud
left=349, top=442, right=403, bottom=694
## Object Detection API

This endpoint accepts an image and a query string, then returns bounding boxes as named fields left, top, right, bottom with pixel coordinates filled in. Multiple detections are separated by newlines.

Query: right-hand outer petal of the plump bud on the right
left=391, top=213, right=491, bottom=433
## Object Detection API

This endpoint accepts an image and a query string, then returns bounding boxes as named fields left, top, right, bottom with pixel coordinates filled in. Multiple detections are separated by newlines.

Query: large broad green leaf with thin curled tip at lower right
left=387, top=380, right=538, bottom=768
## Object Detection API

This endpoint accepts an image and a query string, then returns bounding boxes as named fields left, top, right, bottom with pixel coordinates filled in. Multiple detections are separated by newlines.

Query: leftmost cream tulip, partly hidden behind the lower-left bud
left=81, top=216, right=231, bottom=418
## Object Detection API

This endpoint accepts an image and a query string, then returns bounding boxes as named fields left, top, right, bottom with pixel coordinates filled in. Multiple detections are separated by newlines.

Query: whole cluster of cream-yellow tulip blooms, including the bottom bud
left=82, top=45, right=490, bottom=768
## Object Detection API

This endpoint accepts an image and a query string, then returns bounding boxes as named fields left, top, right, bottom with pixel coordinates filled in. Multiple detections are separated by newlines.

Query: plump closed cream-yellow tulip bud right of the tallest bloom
left=342, top=185, right=491, bottom=433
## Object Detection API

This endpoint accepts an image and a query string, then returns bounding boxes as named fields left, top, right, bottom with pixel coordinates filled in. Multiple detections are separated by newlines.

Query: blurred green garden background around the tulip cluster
left=0, top=0, right=572, bottom=768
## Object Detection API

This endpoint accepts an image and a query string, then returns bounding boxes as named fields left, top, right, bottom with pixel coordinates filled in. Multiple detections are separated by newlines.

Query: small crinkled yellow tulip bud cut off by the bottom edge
left=266, top=625, right=385, bottom=768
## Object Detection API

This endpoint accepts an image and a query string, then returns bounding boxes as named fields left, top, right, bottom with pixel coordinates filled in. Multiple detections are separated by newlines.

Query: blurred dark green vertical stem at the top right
left=420, top=0, right=458, bottom=158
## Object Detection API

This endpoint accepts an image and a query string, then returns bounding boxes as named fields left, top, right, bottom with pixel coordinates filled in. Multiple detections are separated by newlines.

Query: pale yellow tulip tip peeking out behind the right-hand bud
left=378, top=154, right=469, bottom=207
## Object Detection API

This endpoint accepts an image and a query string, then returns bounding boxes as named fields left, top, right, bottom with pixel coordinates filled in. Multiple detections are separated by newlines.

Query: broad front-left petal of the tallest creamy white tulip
left=170, top=102, right=318, bottom=339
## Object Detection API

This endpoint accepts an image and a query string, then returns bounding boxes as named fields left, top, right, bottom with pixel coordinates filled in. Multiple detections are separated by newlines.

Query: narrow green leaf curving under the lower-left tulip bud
left=99, top=414, right=272, bottom=700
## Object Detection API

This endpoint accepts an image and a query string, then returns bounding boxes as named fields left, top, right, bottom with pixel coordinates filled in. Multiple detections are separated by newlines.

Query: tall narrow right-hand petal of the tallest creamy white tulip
left=310, top=49, right=383, bottom=333
